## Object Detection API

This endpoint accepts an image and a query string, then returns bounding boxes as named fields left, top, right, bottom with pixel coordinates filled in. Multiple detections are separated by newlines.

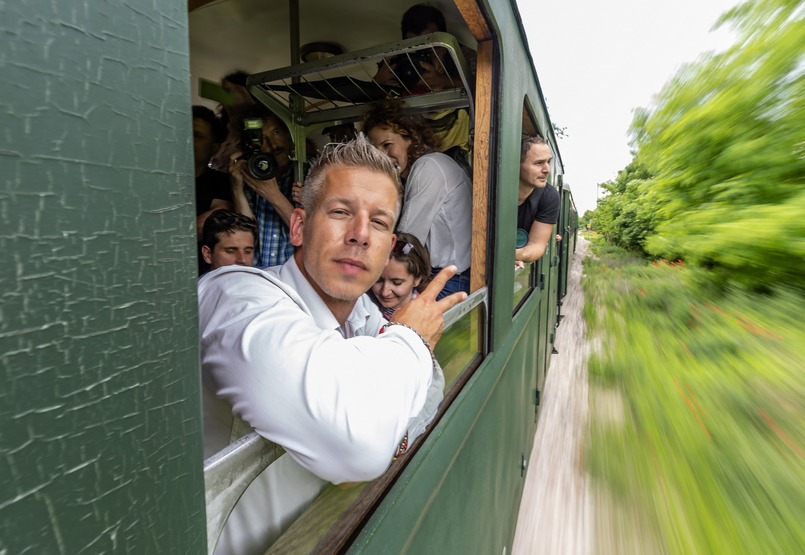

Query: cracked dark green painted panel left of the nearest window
left=0, top=0, right=205, bottom=555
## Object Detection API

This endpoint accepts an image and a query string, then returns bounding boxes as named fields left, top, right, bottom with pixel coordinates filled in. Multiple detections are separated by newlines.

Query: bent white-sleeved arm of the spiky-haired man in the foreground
left=199, top=272, right=433, bottom=484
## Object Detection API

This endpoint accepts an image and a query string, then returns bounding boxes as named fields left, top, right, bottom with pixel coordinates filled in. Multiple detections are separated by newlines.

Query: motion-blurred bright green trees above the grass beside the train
left=593, top=0, right=805, bottom=289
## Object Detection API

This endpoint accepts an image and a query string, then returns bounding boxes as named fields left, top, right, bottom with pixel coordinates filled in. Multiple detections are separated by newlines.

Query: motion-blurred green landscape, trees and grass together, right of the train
left=582, top=0, right=805, bottom=554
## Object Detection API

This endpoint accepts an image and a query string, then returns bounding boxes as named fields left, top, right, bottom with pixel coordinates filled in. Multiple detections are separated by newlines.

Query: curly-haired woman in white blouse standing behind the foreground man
left=363, top=101, right=472, bottom=295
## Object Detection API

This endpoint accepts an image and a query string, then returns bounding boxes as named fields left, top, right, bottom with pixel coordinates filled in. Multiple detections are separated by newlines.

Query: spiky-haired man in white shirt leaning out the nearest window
left=198, top=136, right=466, bottom=555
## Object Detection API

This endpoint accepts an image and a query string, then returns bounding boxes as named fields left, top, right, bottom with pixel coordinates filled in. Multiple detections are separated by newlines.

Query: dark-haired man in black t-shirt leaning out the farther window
left=514, top=135, right=561, bottom=268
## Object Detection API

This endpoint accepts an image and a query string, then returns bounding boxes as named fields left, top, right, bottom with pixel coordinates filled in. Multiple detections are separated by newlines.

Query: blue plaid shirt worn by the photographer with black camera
left=243, top=162, right=304, bottom=268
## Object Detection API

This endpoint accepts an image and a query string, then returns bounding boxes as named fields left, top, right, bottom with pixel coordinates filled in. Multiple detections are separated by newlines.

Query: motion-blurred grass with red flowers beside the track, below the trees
left=583, top=239, right=805, bottom=555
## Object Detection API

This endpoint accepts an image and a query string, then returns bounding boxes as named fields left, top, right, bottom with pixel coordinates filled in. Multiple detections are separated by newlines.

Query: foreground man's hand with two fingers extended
left=392, top=266, right=467, bottom=347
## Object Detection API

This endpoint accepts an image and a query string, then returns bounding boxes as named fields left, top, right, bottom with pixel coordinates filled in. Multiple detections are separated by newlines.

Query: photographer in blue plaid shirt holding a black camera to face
left=229, top=104, right=301, bottom=267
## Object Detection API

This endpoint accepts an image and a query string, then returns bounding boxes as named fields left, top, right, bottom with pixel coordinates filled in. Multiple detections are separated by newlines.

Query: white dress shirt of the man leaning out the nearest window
left=198, top=258, right=436, bottom=555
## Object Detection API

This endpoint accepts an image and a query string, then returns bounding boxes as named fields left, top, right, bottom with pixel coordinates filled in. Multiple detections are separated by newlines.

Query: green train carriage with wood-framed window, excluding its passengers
left=0, top=0, right=576, bottom=553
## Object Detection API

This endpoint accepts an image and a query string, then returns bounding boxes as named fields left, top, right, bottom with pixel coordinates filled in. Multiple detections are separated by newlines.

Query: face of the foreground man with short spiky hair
left=291, top=166, right=397, bottom=302
